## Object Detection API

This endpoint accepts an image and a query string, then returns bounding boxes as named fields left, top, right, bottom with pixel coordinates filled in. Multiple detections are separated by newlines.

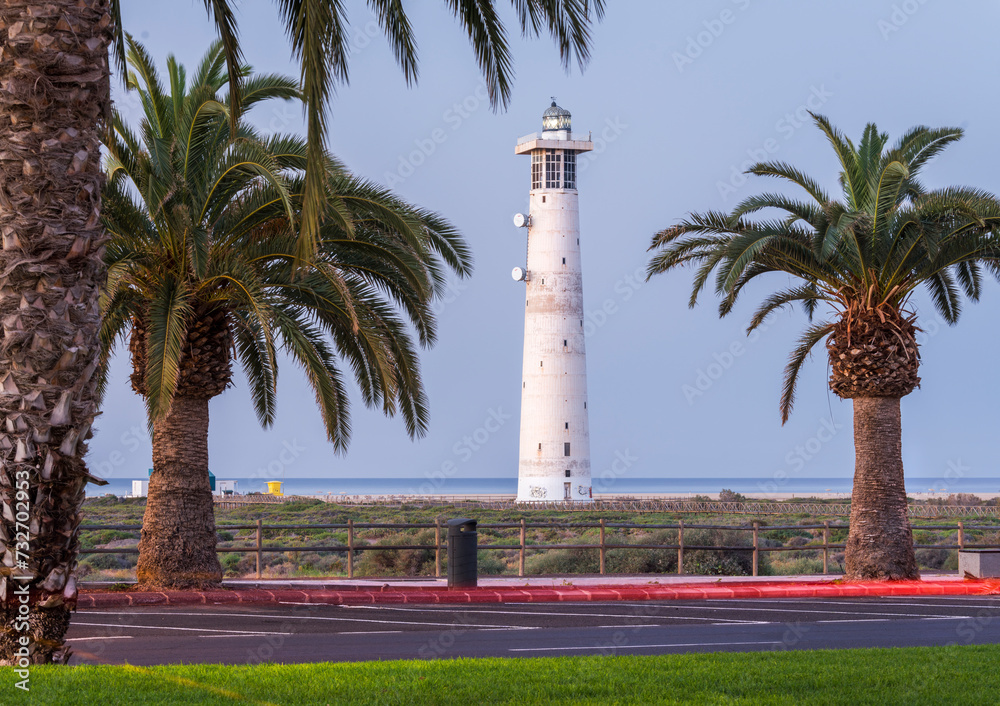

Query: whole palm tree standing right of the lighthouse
left=648, top=115, right=1000, bottom=580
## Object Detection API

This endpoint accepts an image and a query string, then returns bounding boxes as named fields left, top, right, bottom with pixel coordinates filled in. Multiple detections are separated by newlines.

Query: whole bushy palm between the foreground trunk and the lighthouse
left=101, top=38, right=471, bottom=588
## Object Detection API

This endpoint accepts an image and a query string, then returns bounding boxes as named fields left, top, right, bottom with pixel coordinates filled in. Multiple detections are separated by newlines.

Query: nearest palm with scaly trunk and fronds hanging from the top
left=0, top=0, right=604, bottom=665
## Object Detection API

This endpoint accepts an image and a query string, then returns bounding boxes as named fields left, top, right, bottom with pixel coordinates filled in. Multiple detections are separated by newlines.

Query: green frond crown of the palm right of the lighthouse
left=644, top=113, right=1000, bottom=422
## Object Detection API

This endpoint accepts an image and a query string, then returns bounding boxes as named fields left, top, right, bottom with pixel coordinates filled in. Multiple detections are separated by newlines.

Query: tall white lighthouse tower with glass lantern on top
left=513, top=99, right=593, bottom=502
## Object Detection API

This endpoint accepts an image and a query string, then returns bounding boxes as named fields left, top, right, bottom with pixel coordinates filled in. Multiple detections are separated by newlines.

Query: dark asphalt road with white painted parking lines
left=68, top=596, right=1000, bottom=665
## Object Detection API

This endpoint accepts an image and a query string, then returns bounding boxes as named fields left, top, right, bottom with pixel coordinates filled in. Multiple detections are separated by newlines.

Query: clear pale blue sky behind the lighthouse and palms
left=88, top=0, right=1000, bottom=485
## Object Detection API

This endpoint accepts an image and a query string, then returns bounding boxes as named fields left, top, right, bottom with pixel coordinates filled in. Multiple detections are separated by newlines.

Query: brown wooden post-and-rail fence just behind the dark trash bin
left=80, top=518, right=1000, bottom=578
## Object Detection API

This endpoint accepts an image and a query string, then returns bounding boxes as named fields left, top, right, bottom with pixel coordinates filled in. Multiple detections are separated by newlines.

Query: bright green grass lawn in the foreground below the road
left=13, top=645, right=1000, bottom=706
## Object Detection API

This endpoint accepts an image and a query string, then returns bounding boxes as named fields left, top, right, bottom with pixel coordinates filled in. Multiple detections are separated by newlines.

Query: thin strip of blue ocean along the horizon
left=87, top=476, right=1000, bottom=497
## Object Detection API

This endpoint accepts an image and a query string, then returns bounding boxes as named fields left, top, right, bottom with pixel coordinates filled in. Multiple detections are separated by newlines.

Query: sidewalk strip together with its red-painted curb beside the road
left=77, top=574, right=1000, bottom=608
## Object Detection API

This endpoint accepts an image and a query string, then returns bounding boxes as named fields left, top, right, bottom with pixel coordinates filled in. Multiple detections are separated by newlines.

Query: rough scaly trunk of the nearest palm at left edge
left=0, top=0, right=113, bottom=664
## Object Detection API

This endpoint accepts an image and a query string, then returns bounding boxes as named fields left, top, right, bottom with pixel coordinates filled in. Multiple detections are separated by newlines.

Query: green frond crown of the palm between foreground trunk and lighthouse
left=102, top=37, right=472, bottom=451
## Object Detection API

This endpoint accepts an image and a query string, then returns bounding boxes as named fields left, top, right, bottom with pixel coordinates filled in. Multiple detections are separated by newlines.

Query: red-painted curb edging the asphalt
left=77, top=580, right=1000, bottom=608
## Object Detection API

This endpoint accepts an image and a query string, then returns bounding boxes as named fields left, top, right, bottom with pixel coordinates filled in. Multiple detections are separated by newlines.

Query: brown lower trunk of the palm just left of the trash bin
left=136, top=396, right=222, bottom=588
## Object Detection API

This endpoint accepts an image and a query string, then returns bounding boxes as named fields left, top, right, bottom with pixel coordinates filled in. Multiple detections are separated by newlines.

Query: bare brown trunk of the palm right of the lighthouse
left=846, top=397, right=919, bottom=581
